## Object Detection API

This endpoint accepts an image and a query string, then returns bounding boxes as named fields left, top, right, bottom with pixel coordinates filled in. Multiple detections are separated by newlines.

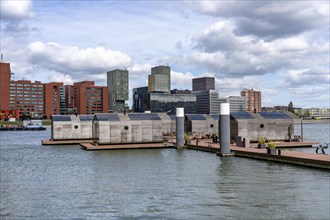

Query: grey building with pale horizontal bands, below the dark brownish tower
left=192, top=90, right=220, bottom=114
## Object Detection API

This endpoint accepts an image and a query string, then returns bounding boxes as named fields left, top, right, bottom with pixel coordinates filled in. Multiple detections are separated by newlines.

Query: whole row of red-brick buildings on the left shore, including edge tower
left=0, top=63, right=109, bottom=118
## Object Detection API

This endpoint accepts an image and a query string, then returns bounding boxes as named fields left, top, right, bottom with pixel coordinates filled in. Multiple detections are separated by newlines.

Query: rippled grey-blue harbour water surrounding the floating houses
left=0, top=124, right=330, bottom=220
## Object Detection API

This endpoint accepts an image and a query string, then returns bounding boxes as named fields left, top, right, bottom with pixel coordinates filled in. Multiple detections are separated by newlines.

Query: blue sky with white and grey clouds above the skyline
left=0, top=0, right=330, bottom=108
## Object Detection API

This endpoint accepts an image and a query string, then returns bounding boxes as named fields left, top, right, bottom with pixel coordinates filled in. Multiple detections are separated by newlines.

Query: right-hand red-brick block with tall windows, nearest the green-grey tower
left=65, top=81, right=109, bottom=114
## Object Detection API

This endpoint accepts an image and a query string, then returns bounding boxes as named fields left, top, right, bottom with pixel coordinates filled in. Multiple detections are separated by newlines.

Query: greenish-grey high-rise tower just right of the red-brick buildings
left=107, top=69, right=128, bottom=112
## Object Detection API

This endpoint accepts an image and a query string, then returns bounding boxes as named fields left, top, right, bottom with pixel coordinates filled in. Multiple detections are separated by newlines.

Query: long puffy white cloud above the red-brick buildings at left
left=28, top=41, right=132, bottom=78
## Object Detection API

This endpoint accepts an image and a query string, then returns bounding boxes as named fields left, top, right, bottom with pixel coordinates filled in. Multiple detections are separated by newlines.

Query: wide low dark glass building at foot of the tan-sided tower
left=149, top=93, right=196, bottom=115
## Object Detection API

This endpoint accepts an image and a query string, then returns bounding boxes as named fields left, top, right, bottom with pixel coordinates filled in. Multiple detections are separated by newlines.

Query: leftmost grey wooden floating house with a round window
left=51, top=115, right=94, bottom=141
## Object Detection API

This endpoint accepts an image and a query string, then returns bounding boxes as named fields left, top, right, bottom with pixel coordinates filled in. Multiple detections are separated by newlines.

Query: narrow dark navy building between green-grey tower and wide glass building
left=133, top=86, right=150, bottom=112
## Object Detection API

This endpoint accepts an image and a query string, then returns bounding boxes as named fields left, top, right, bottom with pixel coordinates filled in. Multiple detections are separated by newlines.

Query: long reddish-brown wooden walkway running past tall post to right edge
left=188, top=140, right=330, bottom=169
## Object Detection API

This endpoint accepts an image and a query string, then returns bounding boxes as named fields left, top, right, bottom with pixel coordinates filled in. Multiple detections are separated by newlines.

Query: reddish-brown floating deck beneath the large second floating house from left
left=80, top=143, right=174, bottom=151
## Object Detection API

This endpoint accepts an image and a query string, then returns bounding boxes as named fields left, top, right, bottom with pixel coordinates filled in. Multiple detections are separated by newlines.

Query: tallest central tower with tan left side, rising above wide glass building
left=148, top=66, right=171, bottom=94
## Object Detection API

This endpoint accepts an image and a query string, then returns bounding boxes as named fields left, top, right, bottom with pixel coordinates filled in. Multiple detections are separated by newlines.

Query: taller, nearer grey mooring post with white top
left=219, top=103, right=231, bottom=156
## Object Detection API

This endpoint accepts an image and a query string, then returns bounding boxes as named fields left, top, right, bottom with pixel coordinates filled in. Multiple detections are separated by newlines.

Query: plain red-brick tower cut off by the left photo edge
left=0, top=62, right=10, bottom=110
